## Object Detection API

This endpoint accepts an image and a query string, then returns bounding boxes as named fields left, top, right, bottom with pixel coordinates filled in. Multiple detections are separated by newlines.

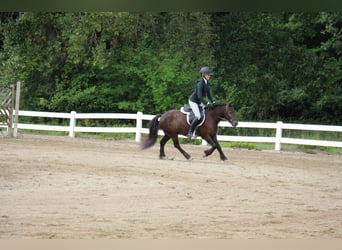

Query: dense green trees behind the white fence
left=0, top=12, right=342, bottom=125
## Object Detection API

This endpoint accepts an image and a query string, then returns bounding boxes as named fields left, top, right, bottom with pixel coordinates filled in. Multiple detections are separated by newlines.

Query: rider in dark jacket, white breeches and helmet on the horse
left=187, top=66, right=215, bottom=138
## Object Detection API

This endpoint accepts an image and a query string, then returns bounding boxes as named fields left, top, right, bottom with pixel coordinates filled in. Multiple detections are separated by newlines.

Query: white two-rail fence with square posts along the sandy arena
left=4, top=110, right=342, bottom=150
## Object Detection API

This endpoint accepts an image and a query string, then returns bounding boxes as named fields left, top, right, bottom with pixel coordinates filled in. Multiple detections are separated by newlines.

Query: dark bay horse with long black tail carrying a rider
left=142, top=104, right=238, bottom=161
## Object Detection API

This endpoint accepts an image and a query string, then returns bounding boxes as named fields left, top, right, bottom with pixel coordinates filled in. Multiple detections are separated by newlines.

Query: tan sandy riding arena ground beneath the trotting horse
left=0, top=134, right=342, bottom=239
